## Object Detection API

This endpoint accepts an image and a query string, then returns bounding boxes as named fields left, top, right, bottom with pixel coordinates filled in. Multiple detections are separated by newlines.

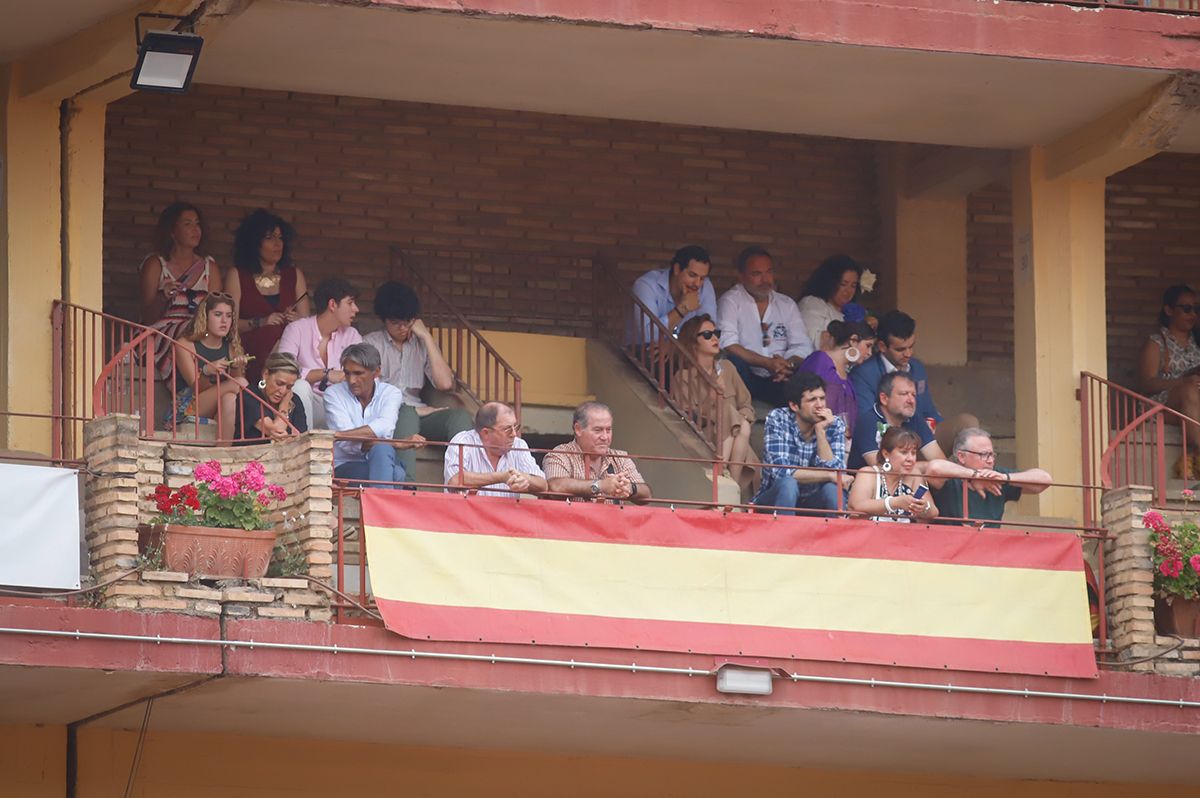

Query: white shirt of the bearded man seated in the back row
left=716, top=283, right=812, bottom=377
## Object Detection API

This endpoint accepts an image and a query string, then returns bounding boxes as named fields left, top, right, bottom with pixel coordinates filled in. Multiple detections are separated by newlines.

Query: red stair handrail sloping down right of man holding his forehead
left=391, top=246, right=521, bottom=421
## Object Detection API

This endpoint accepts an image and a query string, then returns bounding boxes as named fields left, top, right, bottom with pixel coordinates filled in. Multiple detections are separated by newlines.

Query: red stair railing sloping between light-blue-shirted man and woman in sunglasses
left=593, top=258, right=726, bottom=454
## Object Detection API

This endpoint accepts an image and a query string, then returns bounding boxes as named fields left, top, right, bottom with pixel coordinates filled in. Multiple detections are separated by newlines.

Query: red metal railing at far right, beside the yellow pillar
left=1079, top=372, right=1200, bottom=524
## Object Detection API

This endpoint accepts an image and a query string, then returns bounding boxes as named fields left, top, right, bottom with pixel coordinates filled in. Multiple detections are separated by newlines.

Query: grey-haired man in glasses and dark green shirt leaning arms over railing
left=923, top=427, right=1054, bottom=526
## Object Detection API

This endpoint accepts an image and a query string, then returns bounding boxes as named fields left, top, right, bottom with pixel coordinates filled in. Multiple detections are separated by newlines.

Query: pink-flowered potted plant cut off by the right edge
left=1142, top=491, right=1200, bottom=637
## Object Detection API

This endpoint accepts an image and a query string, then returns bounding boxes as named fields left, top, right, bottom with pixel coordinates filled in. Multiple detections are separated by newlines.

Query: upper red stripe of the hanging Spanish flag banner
left=362, top=490, right=1082, bottom=571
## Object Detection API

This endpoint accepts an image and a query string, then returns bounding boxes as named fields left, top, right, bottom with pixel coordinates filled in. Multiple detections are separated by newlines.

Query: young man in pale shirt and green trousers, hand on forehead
left=362, top=281, right=472, bottom=473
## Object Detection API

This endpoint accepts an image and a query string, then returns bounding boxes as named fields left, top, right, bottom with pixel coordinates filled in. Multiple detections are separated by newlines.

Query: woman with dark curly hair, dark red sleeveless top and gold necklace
left=226, top=209, right=308, bottom=383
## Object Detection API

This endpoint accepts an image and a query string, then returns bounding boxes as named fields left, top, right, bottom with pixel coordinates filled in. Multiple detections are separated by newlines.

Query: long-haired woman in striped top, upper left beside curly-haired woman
left=139, top=203, right=221, bottom=379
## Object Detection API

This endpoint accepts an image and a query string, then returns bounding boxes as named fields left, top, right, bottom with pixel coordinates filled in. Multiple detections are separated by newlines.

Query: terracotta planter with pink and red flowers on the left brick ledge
left=138, top=460, right=287, bottom=577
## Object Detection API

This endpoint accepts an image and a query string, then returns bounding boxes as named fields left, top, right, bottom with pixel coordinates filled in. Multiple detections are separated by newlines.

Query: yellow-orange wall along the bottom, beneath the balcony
left=0, top=719, right=1196, bottom=798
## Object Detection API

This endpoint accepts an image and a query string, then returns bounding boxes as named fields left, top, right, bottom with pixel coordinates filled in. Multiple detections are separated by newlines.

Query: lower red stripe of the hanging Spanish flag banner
left=377, top=599, right=1098, bottom=678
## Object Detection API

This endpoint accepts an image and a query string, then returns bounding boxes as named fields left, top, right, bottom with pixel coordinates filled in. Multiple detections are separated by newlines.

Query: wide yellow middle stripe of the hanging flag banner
left=366, top=526, right=1092, bottom=646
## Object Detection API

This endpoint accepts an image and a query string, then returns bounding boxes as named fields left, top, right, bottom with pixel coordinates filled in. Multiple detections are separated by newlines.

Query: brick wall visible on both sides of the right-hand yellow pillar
left=967, top=155, right=1200, bottom=383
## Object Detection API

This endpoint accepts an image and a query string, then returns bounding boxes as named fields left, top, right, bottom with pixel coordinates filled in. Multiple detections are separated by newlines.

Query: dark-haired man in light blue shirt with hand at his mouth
left=632, top=245, right=716, bottom=344
